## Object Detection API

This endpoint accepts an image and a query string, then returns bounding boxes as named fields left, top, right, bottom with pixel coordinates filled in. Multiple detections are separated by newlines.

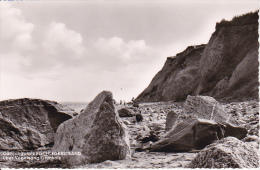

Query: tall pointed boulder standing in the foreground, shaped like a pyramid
left=52, top=91, right=130, bottom=165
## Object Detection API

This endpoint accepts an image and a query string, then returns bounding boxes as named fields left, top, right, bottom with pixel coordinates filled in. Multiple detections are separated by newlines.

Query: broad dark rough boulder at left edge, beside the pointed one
left=0, top=98, right=73, bottom=150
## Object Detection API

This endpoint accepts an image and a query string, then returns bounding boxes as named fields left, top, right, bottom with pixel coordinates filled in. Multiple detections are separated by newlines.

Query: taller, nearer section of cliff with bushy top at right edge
left=196, top=13, right=259, bottom=99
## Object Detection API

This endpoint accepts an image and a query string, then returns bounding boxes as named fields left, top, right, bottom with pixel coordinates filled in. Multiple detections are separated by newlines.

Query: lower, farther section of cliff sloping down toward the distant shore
left=137, top=45, right=205, bottom=102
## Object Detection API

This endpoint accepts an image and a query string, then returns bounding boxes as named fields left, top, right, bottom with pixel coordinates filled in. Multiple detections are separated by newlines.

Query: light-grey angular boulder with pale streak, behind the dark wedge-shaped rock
left=183, top=95, right=239, bottom=126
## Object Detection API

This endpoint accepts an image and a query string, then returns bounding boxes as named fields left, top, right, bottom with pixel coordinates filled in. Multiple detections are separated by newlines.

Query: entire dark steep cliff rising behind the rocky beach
left=137, top=12, right=259, bottom=102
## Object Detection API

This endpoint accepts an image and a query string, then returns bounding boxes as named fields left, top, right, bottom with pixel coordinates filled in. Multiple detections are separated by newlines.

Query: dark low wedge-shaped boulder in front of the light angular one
left=141, top=119, right=224, bottom=152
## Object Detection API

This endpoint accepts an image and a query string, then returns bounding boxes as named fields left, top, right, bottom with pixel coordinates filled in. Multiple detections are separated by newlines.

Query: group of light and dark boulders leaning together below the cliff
left=140, top=96, right=247, bottom=152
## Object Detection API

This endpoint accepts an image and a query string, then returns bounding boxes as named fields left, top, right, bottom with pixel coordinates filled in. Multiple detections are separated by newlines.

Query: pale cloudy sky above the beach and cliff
left=0, top=0, right=258, bottom=102
